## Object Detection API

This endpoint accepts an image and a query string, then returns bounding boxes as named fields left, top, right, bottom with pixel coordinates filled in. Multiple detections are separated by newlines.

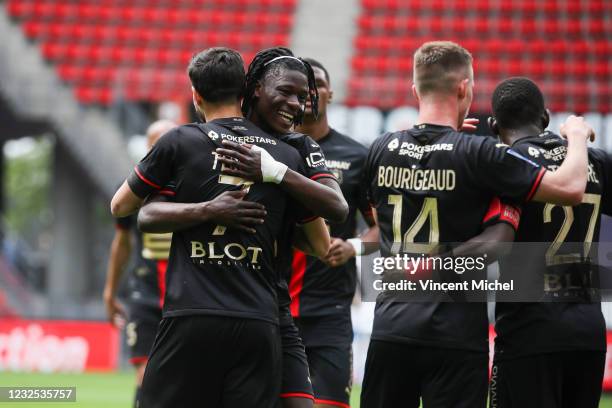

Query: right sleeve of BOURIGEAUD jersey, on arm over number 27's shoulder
left=465, top=136, right=546, bottom=205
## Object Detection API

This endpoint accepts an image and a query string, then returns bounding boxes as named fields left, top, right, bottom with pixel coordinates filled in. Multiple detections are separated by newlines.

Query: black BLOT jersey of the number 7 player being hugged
left=128, top=118, right=305, bottom=322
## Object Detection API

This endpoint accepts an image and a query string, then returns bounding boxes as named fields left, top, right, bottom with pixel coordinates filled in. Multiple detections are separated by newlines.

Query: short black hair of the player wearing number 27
left=491, top=77, right=545, bottom=129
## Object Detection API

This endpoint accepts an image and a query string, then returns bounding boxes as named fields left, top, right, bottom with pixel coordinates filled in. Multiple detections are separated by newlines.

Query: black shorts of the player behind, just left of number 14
left=295, top=314, right=353, bottom=408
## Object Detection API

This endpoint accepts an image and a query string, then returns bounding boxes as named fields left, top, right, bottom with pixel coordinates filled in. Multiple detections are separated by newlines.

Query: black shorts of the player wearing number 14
left=361, top=340, right=489, bottom=408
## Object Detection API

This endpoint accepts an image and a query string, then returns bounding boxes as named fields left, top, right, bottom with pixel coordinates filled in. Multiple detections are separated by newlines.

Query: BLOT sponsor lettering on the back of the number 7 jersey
left=191, top=241, right=263, bottom=269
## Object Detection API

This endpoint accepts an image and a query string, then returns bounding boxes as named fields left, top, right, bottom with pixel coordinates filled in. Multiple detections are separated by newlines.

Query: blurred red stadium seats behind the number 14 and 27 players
left=347, top=0, right=612, bottom=113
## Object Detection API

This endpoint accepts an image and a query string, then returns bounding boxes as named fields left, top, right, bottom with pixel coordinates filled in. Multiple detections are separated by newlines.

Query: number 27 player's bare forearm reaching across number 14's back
left=453, top=222, right=515, bottom=264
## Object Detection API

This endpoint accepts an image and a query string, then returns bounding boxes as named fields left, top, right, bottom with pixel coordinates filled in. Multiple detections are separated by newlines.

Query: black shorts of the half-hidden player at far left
left=125, top=303, right=161, bottom=365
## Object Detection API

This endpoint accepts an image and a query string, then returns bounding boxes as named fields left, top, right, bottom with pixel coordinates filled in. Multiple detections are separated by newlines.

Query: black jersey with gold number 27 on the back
left=495, top=132, right=612, bottom=359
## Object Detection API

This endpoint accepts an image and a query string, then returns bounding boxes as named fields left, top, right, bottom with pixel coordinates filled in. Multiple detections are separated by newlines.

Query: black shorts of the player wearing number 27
left=489, top=351, right=606, bottom=408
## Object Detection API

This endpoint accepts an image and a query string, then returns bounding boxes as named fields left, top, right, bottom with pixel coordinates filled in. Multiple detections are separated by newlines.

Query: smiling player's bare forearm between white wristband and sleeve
left=280, top=169, right=349, bottom=222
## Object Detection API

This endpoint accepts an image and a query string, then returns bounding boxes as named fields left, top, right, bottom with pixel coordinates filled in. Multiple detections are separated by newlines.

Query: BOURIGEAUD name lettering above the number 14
left=377, top=166, right=457, bottom=191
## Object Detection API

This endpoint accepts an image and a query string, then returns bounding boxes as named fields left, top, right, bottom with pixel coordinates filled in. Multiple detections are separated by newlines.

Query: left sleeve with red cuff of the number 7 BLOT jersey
left=127, top=129, right=180, bottom=198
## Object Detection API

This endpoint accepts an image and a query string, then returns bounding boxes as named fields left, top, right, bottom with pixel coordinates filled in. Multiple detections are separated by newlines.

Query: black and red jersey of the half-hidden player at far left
left=115, top=215, right=172, bottom=307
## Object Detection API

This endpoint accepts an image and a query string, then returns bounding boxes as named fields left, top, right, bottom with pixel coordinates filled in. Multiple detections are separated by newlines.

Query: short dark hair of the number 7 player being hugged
left=187, top=47, right=245, bottom=103
